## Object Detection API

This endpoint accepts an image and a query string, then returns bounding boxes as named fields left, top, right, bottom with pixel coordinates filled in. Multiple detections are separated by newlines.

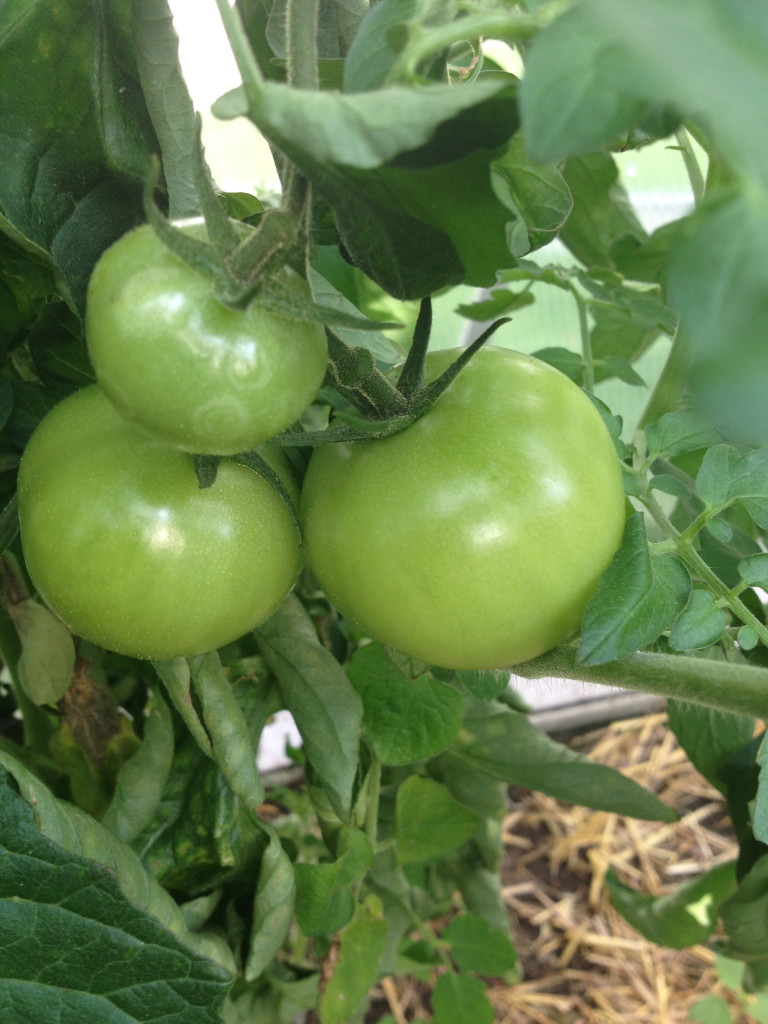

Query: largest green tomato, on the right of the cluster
left=302, top=347, right=625, bottom=669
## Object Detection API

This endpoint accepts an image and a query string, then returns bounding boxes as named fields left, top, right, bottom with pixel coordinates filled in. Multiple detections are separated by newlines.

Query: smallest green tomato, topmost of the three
left=86, top=223, right=328, bottom=455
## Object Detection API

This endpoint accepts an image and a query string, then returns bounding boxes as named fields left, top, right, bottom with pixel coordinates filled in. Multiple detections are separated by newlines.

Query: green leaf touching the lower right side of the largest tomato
left=579, top=512, right=690, bottom=665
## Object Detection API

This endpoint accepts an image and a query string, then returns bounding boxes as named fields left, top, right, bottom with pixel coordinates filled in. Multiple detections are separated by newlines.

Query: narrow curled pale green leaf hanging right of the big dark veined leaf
left=245, top=824, right=296, bottom=981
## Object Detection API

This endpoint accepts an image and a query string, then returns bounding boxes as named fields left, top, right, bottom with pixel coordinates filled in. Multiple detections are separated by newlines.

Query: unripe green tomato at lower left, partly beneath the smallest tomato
left=18, top=385, right=302, bottom=658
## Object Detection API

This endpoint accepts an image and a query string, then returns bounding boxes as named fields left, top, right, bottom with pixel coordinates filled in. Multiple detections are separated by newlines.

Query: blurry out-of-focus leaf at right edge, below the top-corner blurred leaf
left=669, top=193, right=768, bottom=444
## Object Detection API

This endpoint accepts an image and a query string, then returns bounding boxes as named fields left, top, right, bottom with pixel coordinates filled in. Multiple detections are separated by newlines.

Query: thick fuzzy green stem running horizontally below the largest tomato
left=514, top=647, right=768, bottom=719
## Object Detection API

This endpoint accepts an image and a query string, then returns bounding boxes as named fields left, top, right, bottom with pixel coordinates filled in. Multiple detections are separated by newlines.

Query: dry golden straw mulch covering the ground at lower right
left=382, top=714, right=751, bottom=1024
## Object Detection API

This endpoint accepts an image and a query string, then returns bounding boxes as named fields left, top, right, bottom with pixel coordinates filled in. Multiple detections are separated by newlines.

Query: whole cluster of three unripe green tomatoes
left=18, top=227, right=625, bottom=669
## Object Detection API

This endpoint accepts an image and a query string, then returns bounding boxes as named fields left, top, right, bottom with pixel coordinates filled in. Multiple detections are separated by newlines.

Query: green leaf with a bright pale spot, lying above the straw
left=606, top=862, right=736, bottom=949
